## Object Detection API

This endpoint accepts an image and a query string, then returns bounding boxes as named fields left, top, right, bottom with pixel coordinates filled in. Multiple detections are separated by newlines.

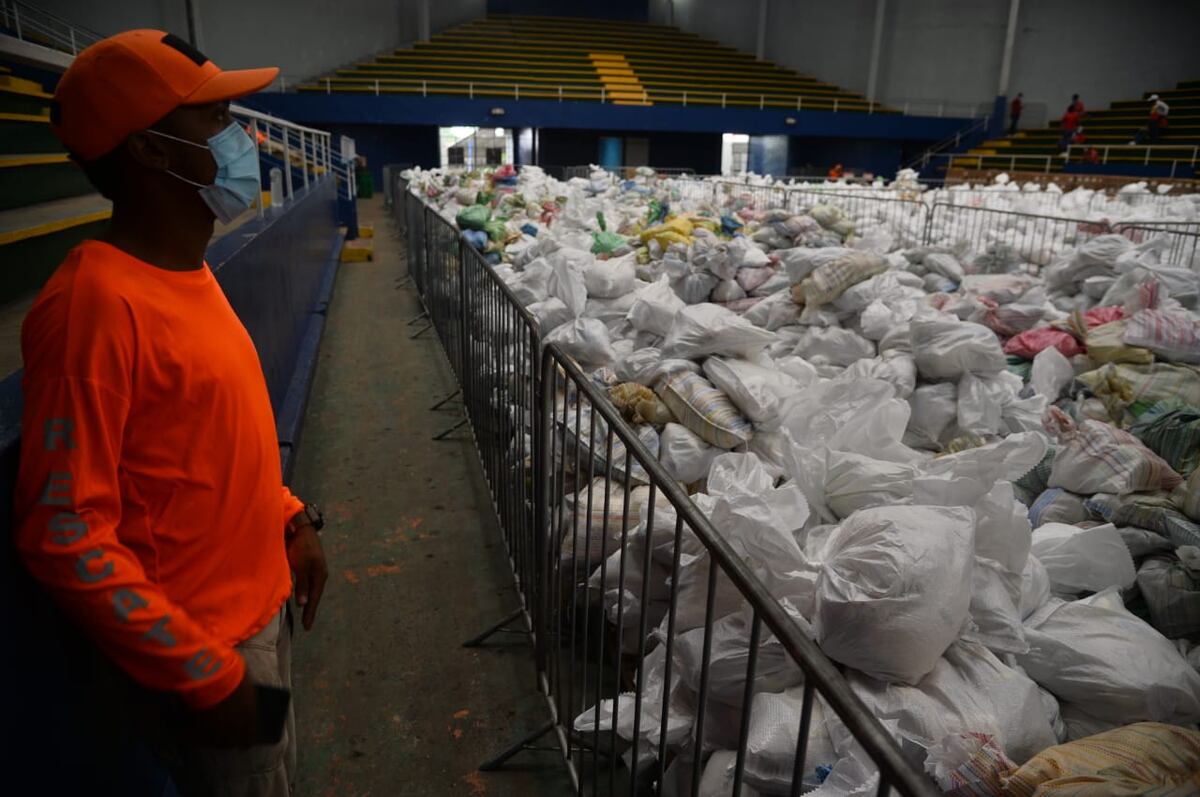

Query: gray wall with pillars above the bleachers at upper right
left=649, top=0, right=1200, bottom=122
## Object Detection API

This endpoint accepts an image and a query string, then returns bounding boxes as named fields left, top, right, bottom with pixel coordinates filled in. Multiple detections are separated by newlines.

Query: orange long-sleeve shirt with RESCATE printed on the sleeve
left=14, top=241, right=302, bottom=708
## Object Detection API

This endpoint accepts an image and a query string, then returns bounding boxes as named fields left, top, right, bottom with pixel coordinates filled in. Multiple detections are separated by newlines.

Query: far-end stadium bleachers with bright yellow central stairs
left=298, top=14, right=895, bottom=113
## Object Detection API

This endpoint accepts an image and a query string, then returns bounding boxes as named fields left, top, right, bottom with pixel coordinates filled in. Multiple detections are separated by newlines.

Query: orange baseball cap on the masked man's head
left=50, top=30, right=280, bottom=161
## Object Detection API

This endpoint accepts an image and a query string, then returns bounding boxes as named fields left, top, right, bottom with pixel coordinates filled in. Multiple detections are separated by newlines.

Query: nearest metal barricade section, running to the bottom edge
left=535, top=344, right=940, bottom=797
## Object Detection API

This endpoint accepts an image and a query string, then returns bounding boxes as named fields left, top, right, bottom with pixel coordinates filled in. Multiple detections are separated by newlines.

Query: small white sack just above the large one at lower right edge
left=1032, top=523, right=1138, bottom=594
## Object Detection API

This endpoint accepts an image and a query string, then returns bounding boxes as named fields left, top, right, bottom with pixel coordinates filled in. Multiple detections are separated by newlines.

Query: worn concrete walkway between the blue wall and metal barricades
left=294, top=197, right=570, bottom=797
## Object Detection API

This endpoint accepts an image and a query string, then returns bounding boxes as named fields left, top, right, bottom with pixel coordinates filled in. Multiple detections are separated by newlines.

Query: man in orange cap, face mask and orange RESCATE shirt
left=14, top=30, right=328, bottom=797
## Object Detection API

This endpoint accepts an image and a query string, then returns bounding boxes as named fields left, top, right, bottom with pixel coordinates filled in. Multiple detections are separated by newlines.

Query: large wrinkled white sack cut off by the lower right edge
left=1016, top=593, right=1200, bottom=723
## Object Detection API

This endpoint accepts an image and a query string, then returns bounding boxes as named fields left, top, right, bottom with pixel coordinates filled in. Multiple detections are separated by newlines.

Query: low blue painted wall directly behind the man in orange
left=0, top=172, right=337, bottom=797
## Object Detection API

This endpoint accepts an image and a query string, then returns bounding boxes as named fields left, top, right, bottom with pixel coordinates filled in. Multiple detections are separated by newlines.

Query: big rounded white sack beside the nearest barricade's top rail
left=812, top=507, right=974, bottom=684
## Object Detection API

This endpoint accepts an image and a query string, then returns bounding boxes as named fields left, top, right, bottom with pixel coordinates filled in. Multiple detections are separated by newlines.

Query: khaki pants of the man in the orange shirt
left=158, top=603, right=296, bottom=797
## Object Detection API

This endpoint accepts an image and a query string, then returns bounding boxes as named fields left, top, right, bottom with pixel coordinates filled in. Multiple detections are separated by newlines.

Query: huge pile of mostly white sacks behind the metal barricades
left=412, top=164, right=1200, bottom=795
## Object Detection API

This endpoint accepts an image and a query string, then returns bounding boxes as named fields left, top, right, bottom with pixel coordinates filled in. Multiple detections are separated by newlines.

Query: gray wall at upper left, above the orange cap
left=36, top=0, right=487, bottom=80
